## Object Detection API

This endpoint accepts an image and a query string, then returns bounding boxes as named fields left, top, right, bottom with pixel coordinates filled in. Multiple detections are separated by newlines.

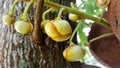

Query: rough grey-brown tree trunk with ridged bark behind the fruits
left=0, top=0, right=73, bottom=68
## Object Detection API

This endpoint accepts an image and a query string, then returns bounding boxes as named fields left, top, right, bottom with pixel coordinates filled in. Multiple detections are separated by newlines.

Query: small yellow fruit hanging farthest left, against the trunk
left=2, top=15, right=15, bottom=25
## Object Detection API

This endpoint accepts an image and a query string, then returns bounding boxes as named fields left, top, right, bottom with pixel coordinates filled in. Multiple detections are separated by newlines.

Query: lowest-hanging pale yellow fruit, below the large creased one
left=63, top=45, right=85, bottom=62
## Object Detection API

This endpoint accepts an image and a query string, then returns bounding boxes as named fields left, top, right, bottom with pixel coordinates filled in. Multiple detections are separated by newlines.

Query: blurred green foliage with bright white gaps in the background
left=77, top=0, right=105, bottom=66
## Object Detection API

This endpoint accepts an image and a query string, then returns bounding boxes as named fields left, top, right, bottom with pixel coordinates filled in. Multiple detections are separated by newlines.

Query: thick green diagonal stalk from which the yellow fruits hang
left=44, top=1, right=111, bottom=29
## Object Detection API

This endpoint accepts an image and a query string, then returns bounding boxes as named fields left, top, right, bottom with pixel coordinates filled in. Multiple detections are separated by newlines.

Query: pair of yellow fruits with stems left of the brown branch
left=2, top=0, right=35, bottom=34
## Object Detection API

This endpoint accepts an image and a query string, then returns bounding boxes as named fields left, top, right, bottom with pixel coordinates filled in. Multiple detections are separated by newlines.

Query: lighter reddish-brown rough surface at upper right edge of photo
left=105, top=0, right=120, bottom=41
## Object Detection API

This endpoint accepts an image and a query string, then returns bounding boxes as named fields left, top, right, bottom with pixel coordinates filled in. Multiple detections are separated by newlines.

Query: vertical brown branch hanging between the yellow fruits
left=32, top=0, right=44, bottom=42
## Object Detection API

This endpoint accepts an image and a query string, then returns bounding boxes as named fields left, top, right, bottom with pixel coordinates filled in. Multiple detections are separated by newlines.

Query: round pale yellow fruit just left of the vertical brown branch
left=14, top=21, right=33, bottom=34
